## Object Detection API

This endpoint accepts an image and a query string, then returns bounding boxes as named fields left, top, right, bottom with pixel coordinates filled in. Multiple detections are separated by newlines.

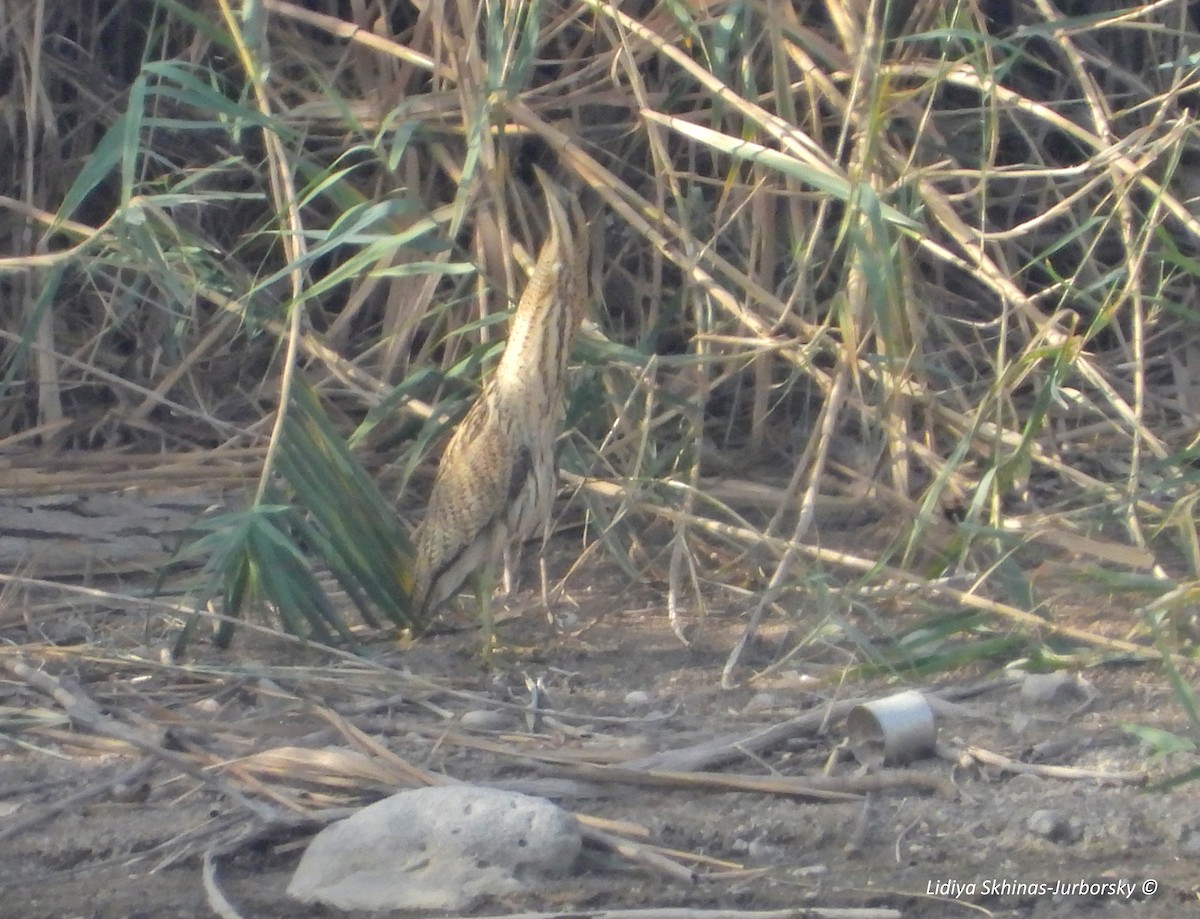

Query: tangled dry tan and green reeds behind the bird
left=0, top=0, right=1200, bottom=668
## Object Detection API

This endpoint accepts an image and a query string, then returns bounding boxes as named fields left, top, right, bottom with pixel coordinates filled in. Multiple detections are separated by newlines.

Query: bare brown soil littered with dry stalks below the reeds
left=0, top=554, right=1200, bottom=919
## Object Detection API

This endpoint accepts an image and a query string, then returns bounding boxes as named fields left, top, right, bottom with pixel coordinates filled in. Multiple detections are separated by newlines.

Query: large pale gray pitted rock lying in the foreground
left=288, top=785, right=582, bottom=909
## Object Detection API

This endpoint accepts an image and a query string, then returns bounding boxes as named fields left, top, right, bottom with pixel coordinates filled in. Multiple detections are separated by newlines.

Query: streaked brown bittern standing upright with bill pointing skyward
left=414, top=170, right=588, bottom=655
